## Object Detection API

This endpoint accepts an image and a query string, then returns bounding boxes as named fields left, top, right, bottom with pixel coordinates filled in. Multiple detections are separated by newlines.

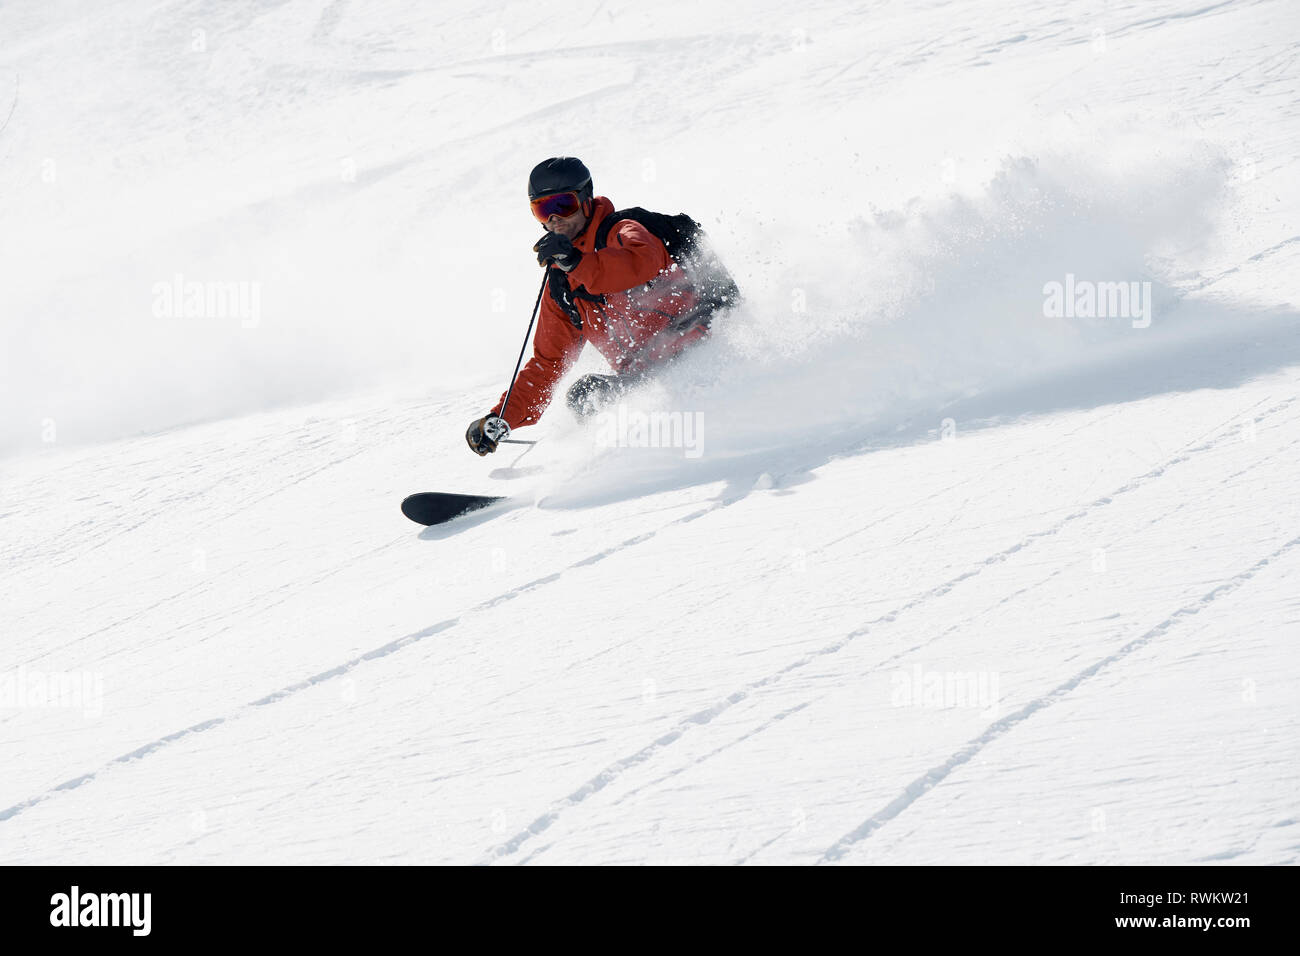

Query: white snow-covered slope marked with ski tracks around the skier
left=0, top=0, right=1300, bottom=864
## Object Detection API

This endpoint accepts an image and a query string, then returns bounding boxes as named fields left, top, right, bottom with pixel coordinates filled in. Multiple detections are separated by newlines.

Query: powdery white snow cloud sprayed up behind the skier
left=553, top=135, right=1229, bottom=503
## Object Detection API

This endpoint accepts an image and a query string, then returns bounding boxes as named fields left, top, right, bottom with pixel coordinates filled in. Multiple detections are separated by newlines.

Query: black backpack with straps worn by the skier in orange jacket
left=549, top=206, right=740, bottom=332
